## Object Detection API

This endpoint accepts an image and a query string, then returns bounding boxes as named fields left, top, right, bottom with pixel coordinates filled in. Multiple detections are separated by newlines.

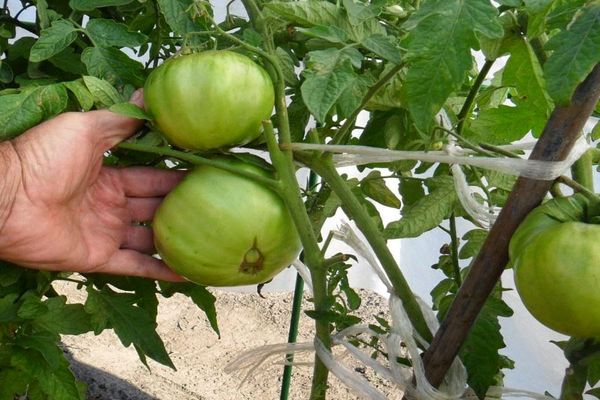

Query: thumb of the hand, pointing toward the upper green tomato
left=89, top=89, right=144, bottom=150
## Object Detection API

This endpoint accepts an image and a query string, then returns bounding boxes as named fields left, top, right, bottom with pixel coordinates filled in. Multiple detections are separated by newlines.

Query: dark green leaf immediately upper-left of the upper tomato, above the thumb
left=81, top=47, right=146, bottom=87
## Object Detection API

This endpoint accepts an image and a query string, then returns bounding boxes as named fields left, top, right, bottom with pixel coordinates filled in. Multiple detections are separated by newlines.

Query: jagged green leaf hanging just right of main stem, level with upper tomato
left=300, top=48, right=362, bottom=122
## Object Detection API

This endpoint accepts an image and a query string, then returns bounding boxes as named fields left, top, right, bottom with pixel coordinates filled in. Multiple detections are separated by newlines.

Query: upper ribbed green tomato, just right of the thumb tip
left=144, top=50, right=274, bottom=150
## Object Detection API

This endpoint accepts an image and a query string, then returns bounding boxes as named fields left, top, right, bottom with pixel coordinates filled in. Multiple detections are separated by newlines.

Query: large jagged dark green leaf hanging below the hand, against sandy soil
left=85, top=286, right=175, bottom=369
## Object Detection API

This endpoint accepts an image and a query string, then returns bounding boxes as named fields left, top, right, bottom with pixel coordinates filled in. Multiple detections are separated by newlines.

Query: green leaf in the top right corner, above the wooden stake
left=544, top=1, right=600, bottom=105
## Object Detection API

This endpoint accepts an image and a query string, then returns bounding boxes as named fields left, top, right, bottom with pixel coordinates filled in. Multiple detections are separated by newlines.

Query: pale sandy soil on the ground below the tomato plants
left=58, top=289, right=400, bottom=400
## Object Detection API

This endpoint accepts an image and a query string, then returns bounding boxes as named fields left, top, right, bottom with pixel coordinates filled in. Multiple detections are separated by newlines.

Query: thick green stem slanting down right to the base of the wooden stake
left=309, top=157, right=432, bottom=341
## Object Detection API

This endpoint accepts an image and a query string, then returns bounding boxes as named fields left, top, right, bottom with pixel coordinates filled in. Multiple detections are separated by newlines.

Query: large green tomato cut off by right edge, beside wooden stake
left=509, top=196, right=600, bottom=337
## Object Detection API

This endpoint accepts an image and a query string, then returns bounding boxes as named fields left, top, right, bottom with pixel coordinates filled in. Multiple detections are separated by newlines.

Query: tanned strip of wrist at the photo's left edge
left=0, top=141, right=21, bottom=236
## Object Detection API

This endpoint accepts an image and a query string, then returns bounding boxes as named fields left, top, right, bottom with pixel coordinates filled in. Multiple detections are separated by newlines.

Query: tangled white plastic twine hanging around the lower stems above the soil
left=225, top=223, right=555, bottom=400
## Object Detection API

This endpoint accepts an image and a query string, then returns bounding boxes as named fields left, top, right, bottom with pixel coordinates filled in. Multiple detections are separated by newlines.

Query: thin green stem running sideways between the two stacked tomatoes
left=117, top=142, right=280, bottom=190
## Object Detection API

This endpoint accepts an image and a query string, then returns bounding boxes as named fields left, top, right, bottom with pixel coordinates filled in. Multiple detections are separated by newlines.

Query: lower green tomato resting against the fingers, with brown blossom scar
left=152, top=159, right=300, bottom=286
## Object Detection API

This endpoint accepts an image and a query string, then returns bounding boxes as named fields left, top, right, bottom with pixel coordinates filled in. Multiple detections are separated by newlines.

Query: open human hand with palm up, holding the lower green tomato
left=0, top=92, right=184, bottom=281
